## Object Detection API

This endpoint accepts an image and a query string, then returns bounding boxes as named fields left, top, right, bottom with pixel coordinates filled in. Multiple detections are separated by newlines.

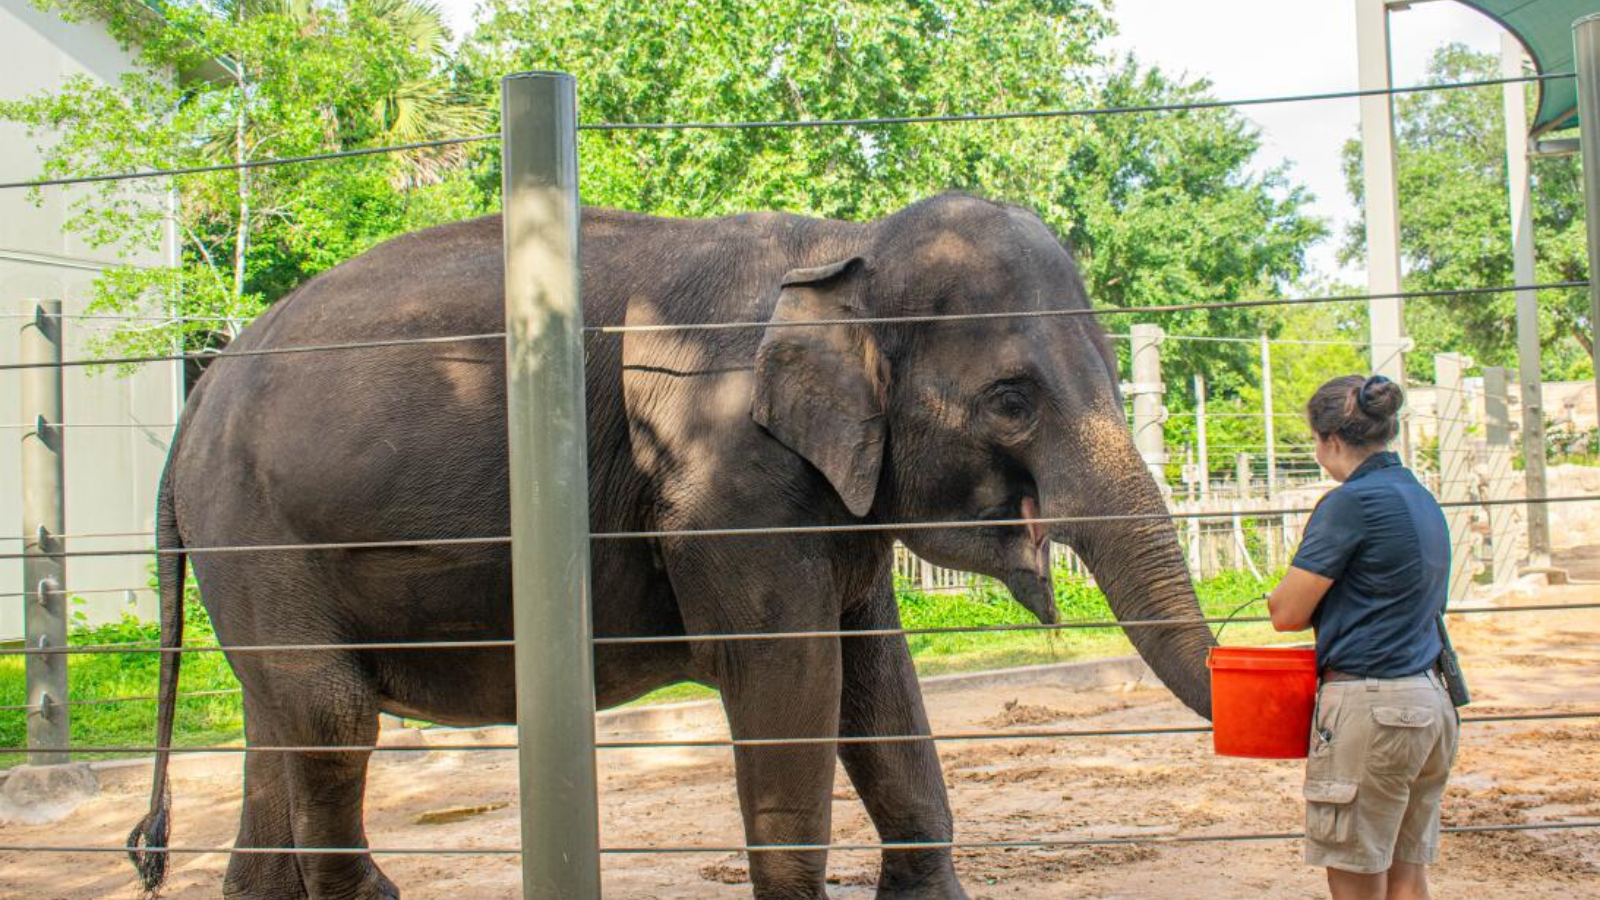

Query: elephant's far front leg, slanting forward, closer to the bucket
left=838, top=580, right=966, bottom=900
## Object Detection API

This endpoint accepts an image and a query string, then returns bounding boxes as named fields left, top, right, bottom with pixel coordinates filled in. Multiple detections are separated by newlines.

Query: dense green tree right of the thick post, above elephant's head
left=461, top=0, right=1322, bottom=381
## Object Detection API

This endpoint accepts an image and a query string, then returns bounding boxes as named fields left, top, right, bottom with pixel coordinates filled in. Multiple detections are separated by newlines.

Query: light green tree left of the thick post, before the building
left=0, top=0, right=486, bottom=352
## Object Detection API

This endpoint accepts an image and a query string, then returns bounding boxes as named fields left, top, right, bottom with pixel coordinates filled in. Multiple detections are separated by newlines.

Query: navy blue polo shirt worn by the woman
left=1293, top=452, right=1450, bottom=677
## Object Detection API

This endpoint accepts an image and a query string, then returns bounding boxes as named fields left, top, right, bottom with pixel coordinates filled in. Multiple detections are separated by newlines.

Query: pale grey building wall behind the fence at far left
left=0, top=0, right=181, bottom=639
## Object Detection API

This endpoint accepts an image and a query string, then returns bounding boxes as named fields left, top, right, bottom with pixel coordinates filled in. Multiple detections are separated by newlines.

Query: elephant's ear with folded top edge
left=750, top=256, right=890, bottom=516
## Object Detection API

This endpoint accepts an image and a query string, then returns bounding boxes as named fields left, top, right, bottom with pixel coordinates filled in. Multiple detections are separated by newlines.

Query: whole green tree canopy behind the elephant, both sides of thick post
left=0, top=0, right=1325, bottom=396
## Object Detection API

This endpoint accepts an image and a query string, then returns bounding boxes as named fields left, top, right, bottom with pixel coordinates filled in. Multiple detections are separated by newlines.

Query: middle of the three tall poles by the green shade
left=1496, top=32, right=1550, bottom=560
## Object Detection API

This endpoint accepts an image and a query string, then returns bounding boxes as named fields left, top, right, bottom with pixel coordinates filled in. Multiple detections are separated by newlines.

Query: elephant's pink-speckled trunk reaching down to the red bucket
left=1045, top=440, right=1216, bottom=719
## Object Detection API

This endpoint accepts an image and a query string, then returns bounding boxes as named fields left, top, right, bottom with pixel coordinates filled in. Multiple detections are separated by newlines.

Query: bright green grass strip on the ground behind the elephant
left=0, top=569, right=1307, bottom=767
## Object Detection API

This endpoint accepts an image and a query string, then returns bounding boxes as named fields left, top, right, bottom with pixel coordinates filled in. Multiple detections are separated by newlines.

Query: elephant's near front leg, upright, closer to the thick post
left=718, top=637, right=840, bottom=900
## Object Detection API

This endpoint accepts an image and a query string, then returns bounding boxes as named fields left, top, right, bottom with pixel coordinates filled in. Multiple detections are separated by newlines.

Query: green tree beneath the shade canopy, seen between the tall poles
left=1342, top=43, right=1592, bottom=380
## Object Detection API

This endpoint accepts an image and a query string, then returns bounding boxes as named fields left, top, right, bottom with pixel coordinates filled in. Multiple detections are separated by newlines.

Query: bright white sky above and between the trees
left=437, top=0, right=1501, bottom=283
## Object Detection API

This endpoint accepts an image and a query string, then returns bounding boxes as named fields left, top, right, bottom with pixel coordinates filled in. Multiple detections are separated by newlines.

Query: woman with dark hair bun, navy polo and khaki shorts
left=1267, top=375, right=1458, bottom=900
